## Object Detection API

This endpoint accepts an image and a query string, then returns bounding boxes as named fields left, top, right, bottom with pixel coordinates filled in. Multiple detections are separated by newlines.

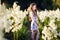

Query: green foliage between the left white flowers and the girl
left=18, top=16, right=30, bottom=40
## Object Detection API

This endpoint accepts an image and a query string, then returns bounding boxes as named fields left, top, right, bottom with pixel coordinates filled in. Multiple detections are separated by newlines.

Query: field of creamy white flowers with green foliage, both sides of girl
left=0, top=3, right=60, bottom=40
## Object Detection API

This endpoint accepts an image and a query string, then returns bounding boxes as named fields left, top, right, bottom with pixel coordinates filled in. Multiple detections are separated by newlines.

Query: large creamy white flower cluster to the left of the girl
left=0, top=2, right=27, bottom=32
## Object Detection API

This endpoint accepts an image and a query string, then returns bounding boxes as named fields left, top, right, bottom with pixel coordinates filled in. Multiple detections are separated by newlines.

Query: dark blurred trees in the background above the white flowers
left=1, top=0, right=60, bottom=10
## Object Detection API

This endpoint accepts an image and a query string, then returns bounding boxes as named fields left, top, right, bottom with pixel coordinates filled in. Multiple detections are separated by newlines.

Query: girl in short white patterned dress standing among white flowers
left=28, top=3, right=39, bottom=40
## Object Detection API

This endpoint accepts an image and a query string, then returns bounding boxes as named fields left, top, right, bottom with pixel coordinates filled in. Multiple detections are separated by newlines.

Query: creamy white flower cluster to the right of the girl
left=38, top=9, right=60, bottom=40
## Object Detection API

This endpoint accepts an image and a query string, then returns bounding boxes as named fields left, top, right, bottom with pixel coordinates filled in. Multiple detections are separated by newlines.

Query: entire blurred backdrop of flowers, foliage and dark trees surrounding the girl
left=0, top=0, right=60, bottom=40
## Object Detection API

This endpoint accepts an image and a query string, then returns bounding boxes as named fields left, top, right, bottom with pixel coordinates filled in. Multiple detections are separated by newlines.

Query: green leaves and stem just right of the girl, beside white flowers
left=39, top=17, right=50, bottom=40
